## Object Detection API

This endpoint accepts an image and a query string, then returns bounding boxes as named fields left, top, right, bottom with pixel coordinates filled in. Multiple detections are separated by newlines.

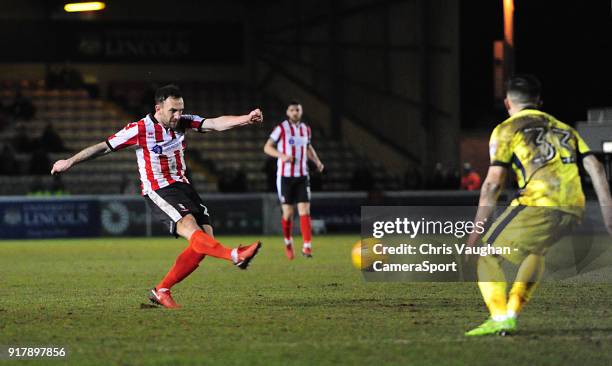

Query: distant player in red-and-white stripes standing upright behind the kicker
left=264, top=101, right=324, bottom=260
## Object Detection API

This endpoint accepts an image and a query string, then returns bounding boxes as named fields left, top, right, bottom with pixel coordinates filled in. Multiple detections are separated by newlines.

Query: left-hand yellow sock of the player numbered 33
left=478, top=256, right=507, bottom=320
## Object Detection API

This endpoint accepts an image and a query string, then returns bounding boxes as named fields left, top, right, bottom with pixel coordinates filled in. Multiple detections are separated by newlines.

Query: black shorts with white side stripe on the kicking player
left=145, top=182, right=210, bottom=237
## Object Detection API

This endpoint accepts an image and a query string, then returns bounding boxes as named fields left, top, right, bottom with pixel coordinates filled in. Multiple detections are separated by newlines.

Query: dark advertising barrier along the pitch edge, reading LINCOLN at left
left=0, top=191, right=601, bottom=239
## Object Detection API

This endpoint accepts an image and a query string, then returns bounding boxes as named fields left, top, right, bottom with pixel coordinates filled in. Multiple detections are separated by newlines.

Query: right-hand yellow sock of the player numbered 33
left=507, top=254, right=544, bottom=317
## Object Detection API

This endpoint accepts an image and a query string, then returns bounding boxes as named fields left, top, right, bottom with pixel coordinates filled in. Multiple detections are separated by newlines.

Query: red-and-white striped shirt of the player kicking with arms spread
left=106, top=114, right=205, bottom=195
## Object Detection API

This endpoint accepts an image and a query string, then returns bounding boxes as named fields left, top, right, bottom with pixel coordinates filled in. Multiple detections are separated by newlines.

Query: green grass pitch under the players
left=0, top=236, right=612, bottom=365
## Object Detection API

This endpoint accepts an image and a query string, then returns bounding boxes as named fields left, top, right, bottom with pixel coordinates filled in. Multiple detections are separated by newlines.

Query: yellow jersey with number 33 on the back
left=489, top=109, right=590, bottom=216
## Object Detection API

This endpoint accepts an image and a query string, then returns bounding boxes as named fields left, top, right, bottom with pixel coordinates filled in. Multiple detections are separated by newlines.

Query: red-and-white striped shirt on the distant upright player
left=270, top=120, right=311, bottom=177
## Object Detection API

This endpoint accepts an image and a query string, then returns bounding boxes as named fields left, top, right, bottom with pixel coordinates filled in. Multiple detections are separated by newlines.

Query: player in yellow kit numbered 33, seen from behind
left=466, top=75, right=612, bottom=336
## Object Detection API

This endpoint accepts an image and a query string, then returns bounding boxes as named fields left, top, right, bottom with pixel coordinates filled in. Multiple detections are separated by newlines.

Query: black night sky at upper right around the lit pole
left=461, top=0, right=612, bottom=129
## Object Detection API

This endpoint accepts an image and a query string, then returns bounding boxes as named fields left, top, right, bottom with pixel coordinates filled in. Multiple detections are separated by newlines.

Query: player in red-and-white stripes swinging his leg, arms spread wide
left=51, top=85, right=263, bottom=308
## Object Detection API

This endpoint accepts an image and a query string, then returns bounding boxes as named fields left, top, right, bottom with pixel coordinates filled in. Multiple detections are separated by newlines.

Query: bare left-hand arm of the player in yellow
left=467, top=165, right=508, bottom=246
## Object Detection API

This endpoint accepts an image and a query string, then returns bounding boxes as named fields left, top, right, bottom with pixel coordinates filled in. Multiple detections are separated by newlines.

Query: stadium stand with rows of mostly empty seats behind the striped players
left=0, top=80, right=400, bottom=195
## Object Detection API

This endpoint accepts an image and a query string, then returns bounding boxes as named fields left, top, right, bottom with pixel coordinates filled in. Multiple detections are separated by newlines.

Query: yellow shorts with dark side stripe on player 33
left=482, top=206, right=580, bottom=264
